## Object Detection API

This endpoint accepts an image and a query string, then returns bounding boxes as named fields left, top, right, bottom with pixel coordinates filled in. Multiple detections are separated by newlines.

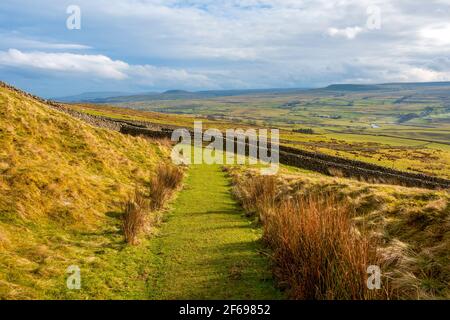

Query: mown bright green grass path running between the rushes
left=148, top=165, right=281, bottom=299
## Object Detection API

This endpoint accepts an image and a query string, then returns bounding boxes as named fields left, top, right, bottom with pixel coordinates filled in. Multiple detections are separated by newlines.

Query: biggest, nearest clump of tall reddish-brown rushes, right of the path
left=264, top=194, right=383, bottom=300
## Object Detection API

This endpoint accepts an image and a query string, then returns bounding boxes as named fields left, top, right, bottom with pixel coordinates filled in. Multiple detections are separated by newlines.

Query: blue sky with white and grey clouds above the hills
left=0, top=0, right=450, bottom=97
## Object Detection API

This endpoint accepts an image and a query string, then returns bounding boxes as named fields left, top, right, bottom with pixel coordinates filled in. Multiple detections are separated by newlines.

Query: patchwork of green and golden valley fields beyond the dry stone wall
left=65, top=84, right=450, bottom=178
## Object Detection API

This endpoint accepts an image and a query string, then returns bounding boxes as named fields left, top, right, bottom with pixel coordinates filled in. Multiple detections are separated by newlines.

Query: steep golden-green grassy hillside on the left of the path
left=0, top=84, right=171, bottom=299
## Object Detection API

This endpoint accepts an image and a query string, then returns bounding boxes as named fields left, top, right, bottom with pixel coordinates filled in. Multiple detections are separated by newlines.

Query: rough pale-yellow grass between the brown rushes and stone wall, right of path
left=229, top=168, right=450, bottom=299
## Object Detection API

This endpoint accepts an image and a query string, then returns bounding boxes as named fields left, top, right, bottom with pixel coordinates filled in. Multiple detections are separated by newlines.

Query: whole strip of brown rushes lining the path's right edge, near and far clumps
left=232, top=170, right=389, bottom=300
